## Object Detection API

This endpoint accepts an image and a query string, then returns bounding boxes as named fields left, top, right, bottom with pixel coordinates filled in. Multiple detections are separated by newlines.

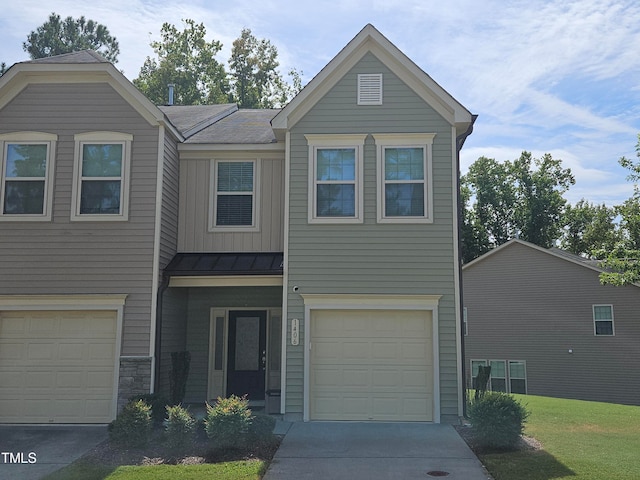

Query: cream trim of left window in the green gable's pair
left=305, top=134, right=367, bottom=224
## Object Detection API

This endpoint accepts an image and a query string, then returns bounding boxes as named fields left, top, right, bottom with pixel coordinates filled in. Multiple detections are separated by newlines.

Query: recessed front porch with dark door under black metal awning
left=156, top=254, right=283, bottom=413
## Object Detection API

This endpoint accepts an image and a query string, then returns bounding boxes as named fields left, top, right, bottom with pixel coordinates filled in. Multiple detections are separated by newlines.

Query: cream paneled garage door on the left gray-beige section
left=0, top=311, right=117, bottom=423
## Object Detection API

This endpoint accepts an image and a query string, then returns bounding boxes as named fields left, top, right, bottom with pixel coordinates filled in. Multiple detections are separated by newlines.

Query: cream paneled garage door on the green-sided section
left=309, top=310, right=433, bottom=421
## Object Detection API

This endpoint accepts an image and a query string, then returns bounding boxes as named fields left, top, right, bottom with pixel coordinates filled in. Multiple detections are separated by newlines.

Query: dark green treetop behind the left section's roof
left=22, top=13, right=120, bottom=63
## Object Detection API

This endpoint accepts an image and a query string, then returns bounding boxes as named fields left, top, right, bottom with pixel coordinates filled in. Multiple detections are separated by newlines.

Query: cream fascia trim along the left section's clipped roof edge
left=0, top=63, right=184, bottom=141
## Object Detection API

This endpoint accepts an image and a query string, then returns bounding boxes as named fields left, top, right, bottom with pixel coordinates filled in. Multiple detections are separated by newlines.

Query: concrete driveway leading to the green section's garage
left=263, top=422, right=491, bottom=480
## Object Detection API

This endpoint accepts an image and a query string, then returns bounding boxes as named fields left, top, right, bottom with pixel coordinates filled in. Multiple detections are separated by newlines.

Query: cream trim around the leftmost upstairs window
left=0, top=132, right=58, bottom=222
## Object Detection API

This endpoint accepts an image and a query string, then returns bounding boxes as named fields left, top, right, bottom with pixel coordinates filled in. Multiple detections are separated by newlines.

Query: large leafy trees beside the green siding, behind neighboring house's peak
left=461, top=152, right=575, bottom=262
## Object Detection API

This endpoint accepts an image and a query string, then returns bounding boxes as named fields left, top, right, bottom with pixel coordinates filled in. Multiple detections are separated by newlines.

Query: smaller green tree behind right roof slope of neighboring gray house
left=560, top=199, right=618, bottom=258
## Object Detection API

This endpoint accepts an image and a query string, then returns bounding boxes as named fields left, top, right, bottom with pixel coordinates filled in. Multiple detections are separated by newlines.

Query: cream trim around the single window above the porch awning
left=209, top=158, right=262, bottom=233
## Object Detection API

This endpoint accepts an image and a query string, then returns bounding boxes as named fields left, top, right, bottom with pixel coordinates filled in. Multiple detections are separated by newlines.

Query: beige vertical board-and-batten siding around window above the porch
left=178, top=153, right=284, bottom=252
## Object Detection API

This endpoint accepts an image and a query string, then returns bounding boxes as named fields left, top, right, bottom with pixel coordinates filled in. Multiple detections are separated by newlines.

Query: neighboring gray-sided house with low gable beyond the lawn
left=462, top=240, right=640, bottom=405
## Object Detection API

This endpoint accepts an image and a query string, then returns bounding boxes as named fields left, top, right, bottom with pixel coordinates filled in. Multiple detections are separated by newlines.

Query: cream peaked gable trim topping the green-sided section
left=271, top=24, right=474, bottom=135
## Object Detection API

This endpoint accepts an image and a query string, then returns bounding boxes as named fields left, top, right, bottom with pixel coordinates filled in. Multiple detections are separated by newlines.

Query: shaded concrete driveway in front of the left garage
left=0, top=425, right=108, bottom=480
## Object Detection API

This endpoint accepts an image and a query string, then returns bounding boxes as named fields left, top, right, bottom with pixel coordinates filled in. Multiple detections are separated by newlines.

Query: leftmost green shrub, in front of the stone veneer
left=109, top=400, right=152, bottom=447
